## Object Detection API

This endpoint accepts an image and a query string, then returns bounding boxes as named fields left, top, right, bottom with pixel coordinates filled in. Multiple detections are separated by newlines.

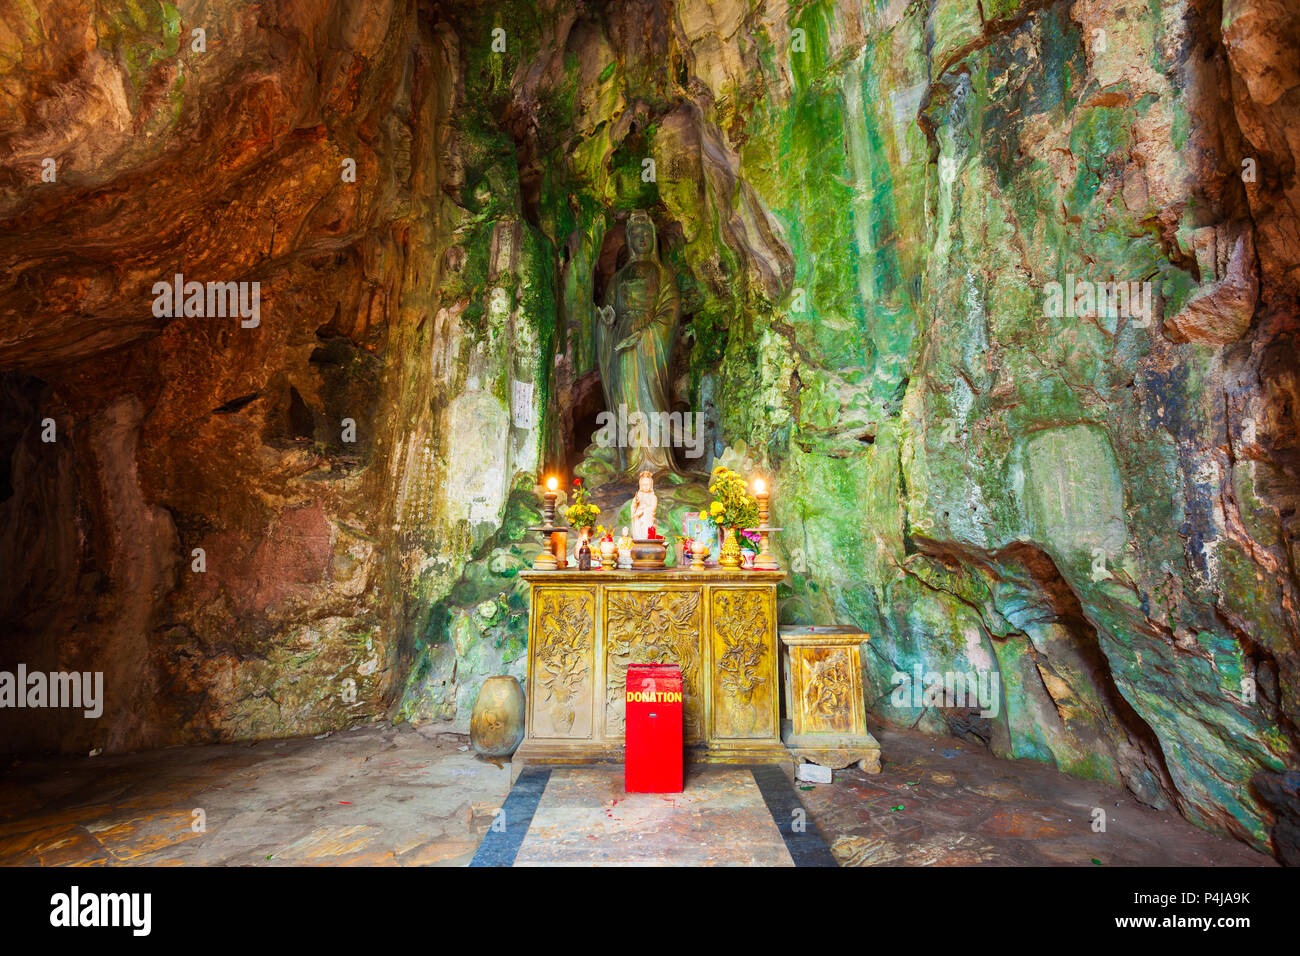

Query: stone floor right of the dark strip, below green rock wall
left=798, top=727, right=1277, bottom=866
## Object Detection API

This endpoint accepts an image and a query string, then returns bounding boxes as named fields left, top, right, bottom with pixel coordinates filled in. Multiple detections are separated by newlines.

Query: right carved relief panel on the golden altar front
left=710, top=588, right=779, bottom=739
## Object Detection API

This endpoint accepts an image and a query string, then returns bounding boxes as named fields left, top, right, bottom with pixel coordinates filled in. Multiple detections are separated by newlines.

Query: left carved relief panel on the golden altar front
left=528, top=588, right=595, bottom=737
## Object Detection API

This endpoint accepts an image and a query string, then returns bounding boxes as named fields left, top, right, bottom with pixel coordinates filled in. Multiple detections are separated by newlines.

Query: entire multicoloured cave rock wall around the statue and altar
left=0, top=0, right=1300, bottom=853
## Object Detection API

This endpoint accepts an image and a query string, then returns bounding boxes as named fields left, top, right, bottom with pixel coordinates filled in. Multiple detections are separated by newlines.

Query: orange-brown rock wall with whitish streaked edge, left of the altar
left=0, top=0, right=554, bottom=752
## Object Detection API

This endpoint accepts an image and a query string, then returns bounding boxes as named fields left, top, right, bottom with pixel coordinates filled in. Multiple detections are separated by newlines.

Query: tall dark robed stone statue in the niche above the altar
left=595, top=209, right=681, bottom=478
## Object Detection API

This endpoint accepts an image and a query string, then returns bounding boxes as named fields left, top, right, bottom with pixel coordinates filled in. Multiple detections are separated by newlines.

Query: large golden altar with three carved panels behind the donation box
left=514, top=568, right=793, bottom=767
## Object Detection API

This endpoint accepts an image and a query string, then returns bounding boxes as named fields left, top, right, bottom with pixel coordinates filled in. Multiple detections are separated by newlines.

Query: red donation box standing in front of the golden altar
left=624, top=663, right=683, bottom=793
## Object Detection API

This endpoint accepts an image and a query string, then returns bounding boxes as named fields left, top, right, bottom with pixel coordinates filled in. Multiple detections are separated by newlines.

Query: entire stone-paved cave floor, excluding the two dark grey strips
left=0, top=724, right=1273, bottom=866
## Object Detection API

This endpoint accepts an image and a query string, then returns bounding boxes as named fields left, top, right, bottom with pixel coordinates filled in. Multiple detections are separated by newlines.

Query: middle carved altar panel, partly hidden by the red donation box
left=605, top=588, right=703, bottom=740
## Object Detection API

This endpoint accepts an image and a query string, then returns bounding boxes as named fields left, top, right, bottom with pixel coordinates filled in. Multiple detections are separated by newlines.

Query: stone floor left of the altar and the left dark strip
left=0, top=724, right=510, bottom=866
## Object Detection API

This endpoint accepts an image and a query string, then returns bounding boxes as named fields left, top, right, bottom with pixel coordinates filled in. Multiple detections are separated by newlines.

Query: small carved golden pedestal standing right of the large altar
left=780, top=624, right=880, bottom=774
